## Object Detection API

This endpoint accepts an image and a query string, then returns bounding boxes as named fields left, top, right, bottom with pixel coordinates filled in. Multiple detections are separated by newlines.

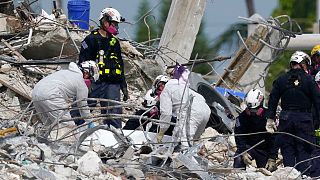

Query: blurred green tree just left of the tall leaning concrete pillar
left=135, top=0, right=158, bottom=42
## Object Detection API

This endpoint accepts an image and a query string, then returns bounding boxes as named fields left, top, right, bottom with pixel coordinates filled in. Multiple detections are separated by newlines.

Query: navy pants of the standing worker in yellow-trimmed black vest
left=88, top=81, right=122, bottom=128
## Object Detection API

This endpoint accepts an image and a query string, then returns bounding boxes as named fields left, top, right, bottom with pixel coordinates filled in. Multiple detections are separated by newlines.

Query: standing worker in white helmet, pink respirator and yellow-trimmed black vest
left=79, top=8, right=129, bottom=128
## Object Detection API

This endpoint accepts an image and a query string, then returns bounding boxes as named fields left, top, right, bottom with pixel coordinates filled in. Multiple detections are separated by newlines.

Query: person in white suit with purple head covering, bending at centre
left=157, top=65, right=211, bottom=147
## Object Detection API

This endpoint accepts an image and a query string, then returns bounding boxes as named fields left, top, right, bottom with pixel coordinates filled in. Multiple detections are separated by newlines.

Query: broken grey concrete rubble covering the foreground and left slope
left=0, top=1, right=312, bottom=180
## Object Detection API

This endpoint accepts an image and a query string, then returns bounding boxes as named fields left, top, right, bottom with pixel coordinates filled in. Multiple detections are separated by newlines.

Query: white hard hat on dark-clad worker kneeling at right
left=244, top=89, right=264, bottom=108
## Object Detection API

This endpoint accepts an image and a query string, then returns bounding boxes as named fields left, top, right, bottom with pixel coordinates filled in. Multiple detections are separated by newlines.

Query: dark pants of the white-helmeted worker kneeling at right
left=233, top=149, right=268, bottom=169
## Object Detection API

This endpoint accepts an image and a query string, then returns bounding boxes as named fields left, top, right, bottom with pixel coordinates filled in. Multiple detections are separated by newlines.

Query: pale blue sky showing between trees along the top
left=39, top=0, right=278, bottom=39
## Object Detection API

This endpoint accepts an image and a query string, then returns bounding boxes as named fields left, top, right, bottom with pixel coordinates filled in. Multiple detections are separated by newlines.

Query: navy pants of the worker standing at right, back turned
left=276, top=111, right=315, bottom=174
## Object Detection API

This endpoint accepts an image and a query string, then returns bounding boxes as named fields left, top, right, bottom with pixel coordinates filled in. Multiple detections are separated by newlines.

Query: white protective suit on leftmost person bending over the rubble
left=32, top=62, right=90, bottom=126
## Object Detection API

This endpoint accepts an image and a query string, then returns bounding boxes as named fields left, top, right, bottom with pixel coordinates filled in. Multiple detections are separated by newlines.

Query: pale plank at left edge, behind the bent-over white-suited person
left=0, top=74, right=32, bottom=101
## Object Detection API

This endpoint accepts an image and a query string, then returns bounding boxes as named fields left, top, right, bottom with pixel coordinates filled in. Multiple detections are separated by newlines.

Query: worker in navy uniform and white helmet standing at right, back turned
left=266, top=51, right=320, bottom=174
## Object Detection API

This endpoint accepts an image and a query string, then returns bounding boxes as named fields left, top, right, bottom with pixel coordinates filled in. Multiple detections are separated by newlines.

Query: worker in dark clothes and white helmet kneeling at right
left=233, top=89, right=278, bottom=171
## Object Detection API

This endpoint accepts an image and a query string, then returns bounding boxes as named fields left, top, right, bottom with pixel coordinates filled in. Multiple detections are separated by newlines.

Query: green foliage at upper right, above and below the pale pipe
left=265, top=0, right=316, bottom=92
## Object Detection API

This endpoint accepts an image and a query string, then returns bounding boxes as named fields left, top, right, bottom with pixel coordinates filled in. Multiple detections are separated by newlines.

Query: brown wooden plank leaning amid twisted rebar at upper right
left=216, top=25, right=268, bottom=89
